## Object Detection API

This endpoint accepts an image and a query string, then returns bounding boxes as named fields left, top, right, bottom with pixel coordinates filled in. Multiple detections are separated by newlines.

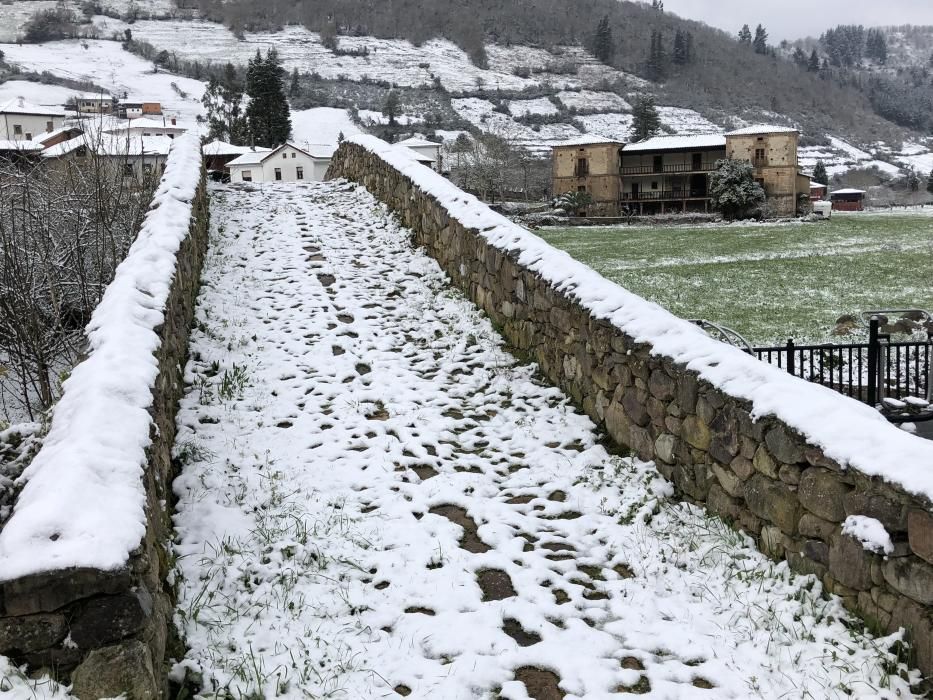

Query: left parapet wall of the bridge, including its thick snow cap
left=0, top=135, right=209, bottom=700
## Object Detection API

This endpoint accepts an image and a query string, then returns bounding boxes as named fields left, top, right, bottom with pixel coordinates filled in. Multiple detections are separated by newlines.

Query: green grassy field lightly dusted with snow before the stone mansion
left=537, top=214, right=933, bottom=345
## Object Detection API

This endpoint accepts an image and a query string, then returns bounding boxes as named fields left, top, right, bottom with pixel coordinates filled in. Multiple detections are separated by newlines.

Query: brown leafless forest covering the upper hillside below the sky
left=178, top=0, right=914, bottom=143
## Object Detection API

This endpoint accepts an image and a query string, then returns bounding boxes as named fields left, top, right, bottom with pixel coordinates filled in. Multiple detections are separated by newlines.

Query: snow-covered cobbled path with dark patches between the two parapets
left=175, top=182, right=910, bottom=700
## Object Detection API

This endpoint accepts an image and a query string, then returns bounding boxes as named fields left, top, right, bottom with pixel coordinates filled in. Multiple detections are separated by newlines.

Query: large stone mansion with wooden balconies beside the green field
left=553, top=126, right=810, bottom=216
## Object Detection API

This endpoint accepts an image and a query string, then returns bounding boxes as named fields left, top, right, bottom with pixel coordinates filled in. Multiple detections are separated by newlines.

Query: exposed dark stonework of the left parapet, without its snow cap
left=0, top=157, right=209, bottom=700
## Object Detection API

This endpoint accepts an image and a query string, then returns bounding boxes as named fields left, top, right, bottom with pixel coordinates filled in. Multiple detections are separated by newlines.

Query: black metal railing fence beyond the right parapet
left=751, top=319, right=933, bottom=406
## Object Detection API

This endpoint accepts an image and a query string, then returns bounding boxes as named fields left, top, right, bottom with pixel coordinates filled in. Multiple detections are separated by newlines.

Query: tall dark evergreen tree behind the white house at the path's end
left=246, top=48, right=292, bottom=148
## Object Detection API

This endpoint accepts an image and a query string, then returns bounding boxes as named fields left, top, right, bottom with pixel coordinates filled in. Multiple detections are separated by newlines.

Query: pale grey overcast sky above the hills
left=652, top=0, right=933, bottom=43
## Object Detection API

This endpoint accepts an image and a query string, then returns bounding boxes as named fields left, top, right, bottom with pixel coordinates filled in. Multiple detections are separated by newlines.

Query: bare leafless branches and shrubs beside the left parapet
left=0, top=139, right=157, bottom=420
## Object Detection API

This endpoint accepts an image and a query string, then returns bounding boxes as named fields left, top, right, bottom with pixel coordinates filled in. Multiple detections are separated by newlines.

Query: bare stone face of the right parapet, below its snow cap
left=328, top=142, right=933, bottom=676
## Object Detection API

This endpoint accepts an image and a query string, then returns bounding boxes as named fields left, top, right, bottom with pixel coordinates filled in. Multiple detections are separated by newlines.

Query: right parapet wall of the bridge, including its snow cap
left=328, top=136, right=933, bottom=677
